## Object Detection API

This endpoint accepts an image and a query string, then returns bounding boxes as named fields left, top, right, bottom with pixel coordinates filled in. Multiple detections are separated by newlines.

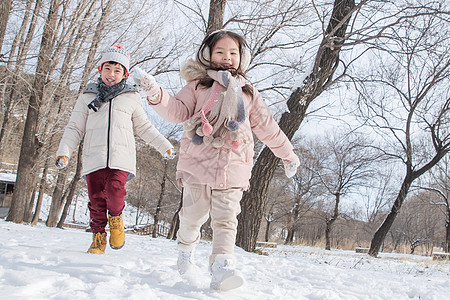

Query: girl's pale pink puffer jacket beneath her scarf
left=152, top=81, right=296, bottom=189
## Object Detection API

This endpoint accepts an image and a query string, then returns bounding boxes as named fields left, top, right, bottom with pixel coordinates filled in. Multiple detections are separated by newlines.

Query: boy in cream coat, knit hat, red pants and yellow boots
left=56, top=45, right=174, bottom=254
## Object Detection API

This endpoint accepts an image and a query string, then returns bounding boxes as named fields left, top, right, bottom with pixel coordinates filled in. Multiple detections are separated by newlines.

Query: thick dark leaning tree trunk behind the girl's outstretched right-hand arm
left=236, top=0, right=355, bottom=251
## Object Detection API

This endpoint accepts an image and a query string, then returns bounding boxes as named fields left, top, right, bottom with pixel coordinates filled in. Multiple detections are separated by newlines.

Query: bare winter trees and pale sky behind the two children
left=0, top=0, right=450, bottom=256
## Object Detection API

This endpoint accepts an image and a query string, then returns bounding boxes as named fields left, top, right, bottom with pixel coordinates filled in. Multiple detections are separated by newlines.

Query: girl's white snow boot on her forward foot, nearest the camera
left=210, top=254, right=244, bottom=291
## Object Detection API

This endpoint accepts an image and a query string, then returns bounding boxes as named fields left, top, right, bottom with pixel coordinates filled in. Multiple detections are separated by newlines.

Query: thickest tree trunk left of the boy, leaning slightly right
left=7, top=0, right=59, bottom=223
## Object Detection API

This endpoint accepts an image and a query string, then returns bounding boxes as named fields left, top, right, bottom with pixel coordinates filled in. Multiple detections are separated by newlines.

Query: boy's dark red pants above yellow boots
left=86, top=168, right=128, bottom=233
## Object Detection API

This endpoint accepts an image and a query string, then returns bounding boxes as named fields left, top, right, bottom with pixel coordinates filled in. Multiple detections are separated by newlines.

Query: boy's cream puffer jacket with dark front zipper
left=56, top=92, right=173, bottom=180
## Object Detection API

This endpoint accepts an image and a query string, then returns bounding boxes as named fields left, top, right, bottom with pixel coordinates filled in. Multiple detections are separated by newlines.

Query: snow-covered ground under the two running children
left=0, top=219, right=450, bottom=300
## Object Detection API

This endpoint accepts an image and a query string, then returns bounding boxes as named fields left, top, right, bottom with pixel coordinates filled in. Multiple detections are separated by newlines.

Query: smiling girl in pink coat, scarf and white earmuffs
left=133, top=30, right=299, bottom=290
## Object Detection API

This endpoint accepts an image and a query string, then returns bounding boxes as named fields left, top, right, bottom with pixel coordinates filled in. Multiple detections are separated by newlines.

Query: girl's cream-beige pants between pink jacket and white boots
left=177, top=184, right=243, bottom=258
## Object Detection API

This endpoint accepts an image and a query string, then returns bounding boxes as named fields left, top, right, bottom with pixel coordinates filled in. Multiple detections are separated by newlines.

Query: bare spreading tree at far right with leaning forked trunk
left=348, top=7, right=450, bottom=256
